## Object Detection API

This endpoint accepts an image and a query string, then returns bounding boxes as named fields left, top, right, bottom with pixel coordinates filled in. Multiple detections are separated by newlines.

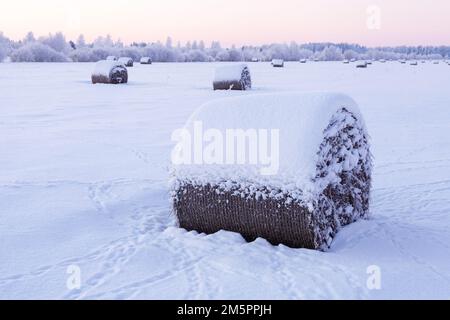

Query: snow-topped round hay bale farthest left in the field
left=91, top=60, right=128, bottom=84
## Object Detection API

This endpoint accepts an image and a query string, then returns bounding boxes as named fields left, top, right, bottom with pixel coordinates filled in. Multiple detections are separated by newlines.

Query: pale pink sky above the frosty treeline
left=0, top=0, right=450, bottom=46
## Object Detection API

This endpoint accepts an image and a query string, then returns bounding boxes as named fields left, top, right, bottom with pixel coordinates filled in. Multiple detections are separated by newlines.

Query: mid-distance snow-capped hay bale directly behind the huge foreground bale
left=213, top=64, right=252, bottom=90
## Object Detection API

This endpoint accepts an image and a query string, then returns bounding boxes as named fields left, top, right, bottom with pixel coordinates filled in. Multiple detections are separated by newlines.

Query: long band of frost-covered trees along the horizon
left=0, top=32, right=450, bottom=62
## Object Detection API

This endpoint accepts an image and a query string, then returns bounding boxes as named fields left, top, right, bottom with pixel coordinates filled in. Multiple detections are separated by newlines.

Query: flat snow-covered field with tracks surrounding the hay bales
left=0, top=62, right=450, bottom=299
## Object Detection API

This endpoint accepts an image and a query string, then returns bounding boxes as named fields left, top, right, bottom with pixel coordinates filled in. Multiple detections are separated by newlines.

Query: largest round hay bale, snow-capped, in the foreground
left=171, top=93, right=372, bottom=250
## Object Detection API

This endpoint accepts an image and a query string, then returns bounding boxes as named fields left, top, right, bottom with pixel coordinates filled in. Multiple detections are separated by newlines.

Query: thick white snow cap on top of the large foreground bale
left=174, top=92, right=364, bottom=200
